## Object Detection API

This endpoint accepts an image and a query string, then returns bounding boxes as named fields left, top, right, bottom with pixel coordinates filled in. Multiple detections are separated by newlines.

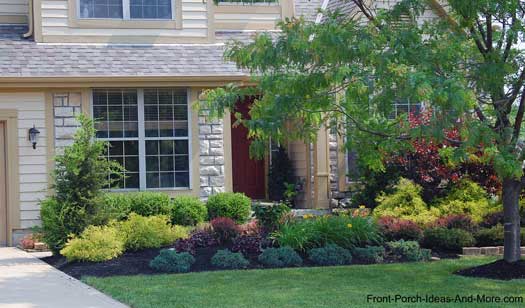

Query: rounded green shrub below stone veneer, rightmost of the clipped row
left=206, top=193, right=252, bottom=223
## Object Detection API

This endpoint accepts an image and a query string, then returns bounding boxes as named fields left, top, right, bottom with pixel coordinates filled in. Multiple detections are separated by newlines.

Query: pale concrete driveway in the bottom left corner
left=0, top=248, right=127, bottom=308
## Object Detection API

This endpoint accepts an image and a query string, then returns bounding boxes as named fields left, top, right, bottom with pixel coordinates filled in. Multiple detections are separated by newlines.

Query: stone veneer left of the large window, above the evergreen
left=53, top=93, right=82, bottom=150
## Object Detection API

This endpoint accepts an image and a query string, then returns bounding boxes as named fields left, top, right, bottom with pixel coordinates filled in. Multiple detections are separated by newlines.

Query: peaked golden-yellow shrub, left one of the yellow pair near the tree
left=373, top=178, right=437, bottom=225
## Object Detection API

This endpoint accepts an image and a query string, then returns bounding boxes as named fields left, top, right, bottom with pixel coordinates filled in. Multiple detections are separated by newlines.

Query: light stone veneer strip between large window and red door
left=199, top=110, right=226, bottom=199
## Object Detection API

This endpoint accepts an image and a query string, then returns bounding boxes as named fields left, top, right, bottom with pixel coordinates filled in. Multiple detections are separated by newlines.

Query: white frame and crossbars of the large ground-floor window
left=89, top=87, right=193, bottom=192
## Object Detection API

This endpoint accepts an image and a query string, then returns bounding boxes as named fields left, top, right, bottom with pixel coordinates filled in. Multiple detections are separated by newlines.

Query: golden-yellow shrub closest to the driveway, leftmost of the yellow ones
left=60, top=226, right=124, bottom=262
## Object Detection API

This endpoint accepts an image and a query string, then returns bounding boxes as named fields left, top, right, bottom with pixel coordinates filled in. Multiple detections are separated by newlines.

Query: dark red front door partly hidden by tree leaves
left=232, top=98, right=266, bottom=200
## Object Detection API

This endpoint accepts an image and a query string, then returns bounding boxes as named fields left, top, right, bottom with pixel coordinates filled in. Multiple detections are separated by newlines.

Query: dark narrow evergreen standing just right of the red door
left=268, top=147, right=295, bottom=202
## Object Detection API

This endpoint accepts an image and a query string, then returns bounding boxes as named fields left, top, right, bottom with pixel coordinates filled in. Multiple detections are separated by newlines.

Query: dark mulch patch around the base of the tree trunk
left=455, top=260, right=525, bottom=280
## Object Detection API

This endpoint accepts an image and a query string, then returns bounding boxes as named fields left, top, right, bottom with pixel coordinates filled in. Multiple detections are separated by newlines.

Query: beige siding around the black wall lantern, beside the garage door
left=0, top=93, right=48, bottom=228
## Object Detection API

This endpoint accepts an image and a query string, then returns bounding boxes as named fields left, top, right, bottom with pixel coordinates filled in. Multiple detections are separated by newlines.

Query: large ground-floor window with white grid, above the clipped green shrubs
left=93, top=89, right=190, bottom=190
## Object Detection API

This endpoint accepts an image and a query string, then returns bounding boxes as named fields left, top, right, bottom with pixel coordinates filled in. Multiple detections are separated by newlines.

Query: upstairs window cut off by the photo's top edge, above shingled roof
left=78, top=0, right=173, bottom=19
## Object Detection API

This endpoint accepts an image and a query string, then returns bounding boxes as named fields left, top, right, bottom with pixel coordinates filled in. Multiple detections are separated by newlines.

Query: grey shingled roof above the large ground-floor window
left=0, top=26, right=247, bottom=80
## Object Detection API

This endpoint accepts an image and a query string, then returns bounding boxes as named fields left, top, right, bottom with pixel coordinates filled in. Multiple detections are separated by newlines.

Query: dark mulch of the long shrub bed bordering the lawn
left=42, top=245, right=457, bottom=279
